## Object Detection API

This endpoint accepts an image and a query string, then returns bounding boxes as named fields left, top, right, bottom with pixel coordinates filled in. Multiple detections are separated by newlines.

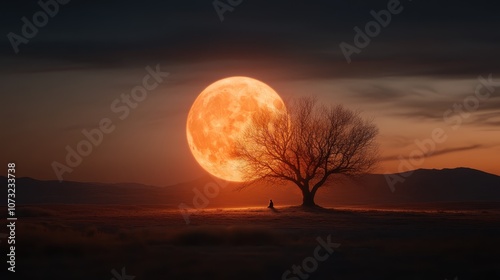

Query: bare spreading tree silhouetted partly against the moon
left=233, top=98, right=378, bottom=207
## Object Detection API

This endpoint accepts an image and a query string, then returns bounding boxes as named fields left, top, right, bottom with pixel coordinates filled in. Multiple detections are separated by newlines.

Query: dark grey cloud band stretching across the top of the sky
left=0, top=0, right=500, bottom=79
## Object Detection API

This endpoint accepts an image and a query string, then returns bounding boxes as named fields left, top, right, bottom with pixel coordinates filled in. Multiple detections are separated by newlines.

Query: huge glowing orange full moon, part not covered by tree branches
left=186, top=77, right=286, bottom=182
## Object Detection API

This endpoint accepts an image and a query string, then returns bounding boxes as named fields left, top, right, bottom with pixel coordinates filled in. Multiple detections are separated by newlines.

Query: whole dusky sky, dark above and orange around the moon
left=0, top=0, right=500, bottom=185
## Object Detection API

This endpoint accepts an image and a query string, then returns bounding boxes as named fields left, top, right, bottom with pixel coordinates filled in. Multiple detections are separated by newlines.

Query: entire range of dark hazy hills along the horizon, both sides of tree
left=0, top=168, right=500, bottom=207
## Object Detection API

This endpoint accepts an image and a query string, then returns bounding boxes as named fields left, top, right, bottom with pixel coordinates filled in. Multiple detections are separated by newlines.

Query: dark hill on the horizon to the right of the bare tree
left=320, top=168, right=500, bottom=204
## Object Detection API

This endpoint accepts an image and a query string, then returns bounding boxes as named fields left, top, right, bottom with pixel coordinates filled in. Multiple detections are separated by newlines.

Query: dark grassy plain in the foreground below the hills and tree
left=0, top=204, right=500, bottom=280
